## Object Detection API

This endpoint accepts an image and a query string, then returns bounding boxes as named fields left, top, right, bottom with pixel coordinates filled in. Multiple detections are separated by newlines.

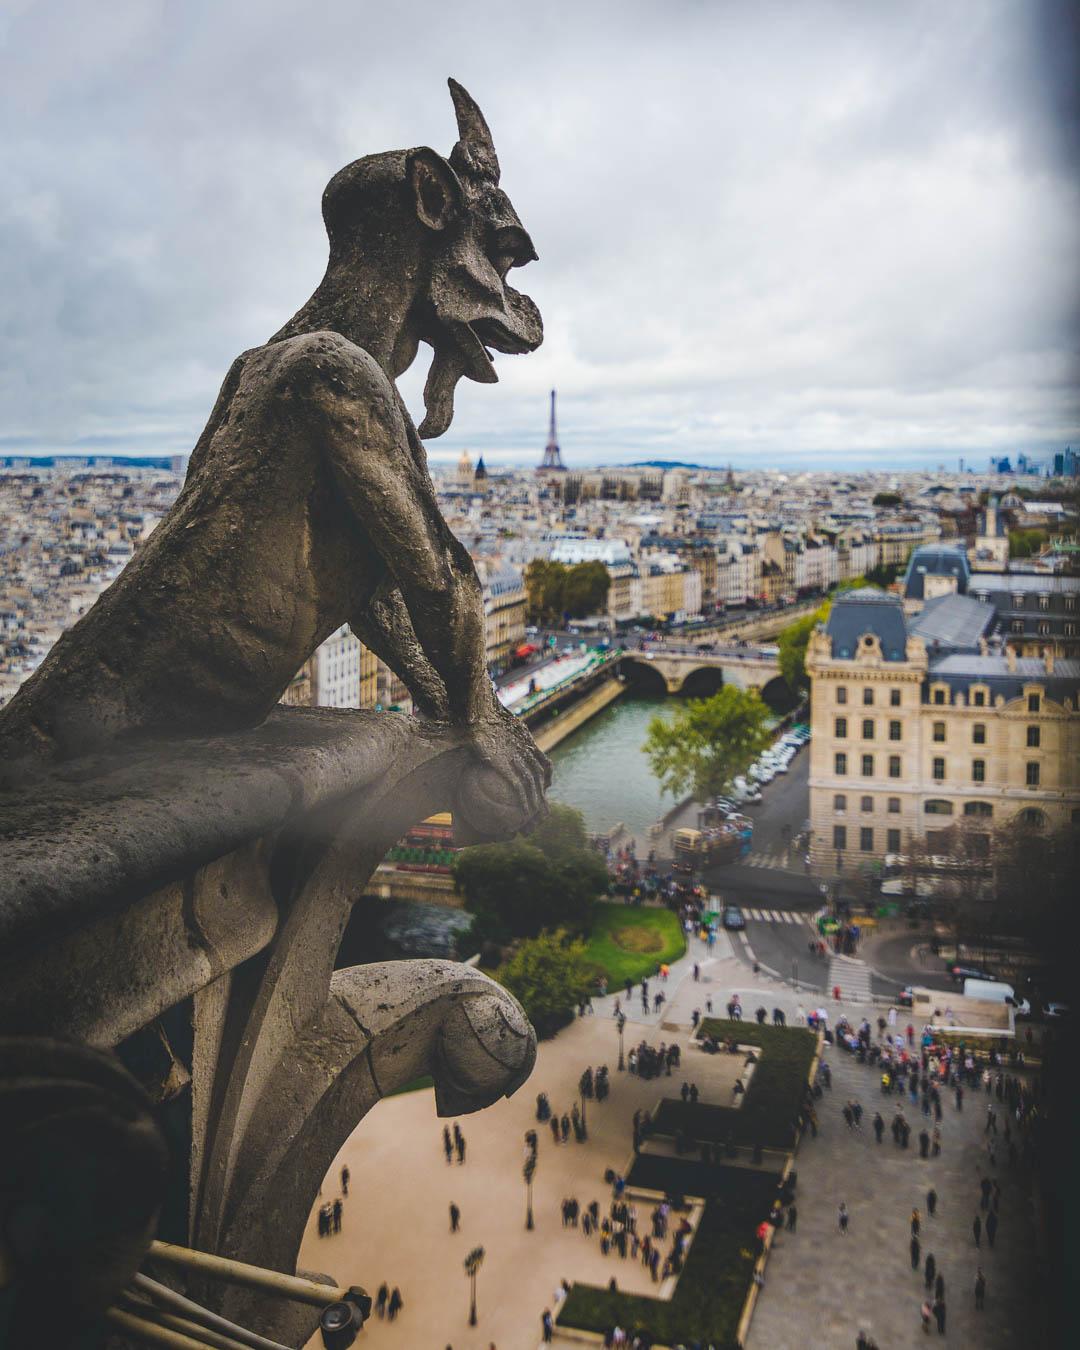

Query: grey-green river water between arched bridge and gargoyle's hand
left=549, top=693, right=675, bottom=853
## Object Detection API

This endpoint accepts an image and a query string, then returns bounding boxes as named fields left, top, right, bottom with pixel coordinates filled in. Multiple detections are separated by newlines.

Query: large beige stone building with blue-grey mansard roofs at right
left=806, top=590, right=1080, bottom=875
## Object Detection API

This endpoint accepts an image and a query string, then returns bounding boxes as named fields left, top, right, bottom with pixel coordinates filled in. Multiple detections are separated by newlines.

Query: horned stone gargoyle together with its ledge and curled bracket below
left=0, top=81, right=549, bottom=1347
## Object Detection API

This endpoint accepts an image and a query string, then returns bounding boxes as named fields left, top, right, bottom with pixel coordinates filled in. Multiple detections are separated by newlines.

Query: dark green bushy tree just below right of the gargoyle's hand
left=454, top=802, right=608, bottom=942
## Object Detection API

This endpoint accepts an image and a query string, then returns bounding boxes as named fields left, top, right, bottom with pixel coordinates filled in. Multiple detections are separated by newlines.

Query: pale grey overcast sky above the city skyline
left=0, top=0, right=1080, bottom=467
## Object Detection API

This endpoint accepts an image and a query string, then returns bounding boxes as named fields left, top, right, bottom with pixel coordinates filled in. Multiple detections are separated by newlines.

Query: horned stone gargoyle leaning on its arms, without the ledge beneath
left=0, top=73, right=549, bottom=838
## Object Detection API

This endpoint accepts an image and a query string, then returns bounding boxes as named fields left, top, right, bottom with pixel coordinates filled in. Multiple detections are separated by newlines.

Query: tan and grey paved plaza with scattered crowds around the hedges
left=301, top=936, right=1034, bottom=1350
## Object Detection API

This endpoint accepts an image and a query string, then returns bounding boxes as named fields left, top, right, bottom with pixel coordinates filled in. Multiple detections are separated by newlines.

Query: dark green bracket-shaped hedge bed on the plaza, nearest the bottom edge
left=559, top=1157, right=779, bottom=1350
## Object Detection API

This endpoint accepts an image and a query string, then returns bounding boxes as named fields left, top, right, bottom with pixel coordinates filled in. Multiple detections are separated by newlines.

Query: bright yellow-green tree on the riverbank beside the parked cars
left=644, top=684, right=771, bottom=802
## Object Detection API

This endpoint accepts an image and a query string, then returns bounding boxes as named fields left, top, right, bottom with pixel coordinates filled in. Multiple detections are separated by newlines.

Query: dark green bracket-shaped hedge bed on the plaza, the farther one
left=656, top=1018, right=817, bottom=1149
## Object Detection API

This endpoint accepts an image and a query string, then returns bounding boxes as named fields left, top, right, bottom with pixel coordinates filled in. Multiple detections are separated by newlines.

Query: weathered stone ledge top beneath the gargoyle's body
left=0, top=709, right=466, bottom=956
